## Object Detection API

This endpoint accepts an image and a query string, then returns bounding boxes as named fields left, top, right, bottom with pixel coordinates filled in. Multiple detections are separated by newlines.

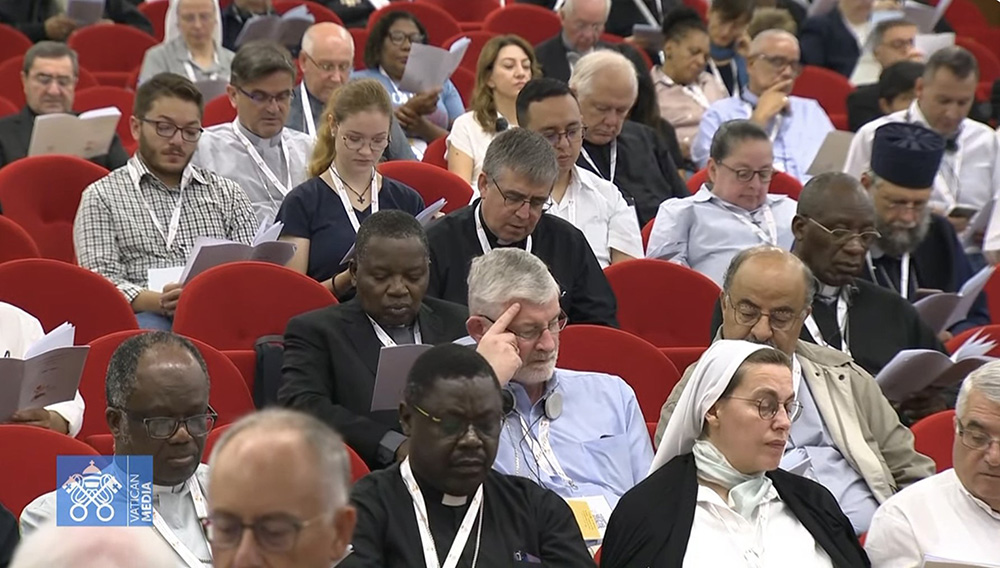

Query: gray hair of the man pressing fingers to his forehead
left=468, top=248, right=559, bottom=317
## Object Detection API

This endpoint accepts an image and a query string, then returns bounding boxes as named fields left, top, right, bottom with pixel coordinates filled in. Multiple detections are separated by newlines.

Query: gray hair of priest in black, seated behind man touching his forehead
left=483, top=128, right=559, bottom=187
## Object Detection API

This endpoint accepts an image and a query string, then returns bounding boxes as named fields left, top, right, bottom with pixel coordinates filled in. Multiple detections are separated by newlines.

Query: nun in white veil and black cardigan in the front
left=601, top=340, right=870, bottom=568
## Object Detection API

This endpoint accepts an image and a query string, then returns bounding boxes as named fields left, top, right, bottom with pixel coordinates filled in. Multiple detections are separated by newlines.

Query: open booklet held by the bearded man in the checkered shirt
left=146, top=217, right=295, bottom=292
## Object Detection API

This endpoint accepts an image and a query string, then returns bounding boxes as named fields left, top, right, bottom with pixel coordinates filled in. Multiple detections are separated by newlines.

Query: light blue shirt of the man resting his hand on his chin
left=691, top=89, right=834, bottom=184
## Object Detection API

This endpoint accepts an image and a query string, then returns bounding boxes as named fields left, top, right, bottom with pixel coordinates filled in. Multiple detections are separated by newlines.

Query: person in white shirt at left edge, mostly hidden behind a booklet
left=0, top=302, right=85, bottom=436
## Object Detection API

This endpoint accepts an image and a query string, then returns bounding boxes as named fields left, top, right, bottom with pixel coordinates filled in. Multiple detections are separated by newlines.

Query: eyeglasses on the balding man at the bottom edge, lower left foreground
left=202, top=512, right=327, bottom=552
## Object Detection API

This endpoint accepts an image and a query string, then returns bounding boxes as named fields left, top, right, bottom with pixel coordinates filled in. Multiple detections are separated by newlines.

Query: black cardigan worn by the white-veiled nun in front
left=601, top=453, right=871, bottom=568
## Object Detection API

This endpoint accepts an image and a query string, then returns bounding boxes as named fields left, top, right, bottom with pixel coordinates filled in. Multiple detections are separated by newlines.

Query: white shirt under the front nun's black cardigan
left=684, top=484, right=833, bottom=568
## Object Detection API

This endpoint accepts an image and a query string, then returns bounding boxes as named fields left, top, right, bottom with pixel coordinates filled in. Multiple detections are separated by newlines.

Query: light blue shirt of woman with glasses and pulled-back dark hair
left=646, top=185, right=796, bottom=286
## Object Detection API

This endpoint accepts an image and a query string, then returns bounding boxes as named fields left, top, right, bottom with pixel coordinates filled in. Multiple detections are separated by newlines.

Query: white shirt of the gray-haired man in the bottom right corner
left=865, top=469, right=1000, bottom=568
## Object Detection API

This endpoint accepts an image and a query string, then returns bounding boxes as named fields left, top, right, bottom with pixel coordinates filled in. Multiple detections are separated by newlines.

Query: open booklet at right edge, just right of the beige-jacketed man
left=875, top=333, right=996, bottom=402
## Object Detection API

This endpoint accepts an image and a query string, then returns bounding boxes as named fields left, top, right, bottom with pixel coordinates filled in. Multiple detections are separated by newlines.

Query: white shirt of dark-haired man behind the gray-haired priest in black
left=548, top=166, right=643, bottom=268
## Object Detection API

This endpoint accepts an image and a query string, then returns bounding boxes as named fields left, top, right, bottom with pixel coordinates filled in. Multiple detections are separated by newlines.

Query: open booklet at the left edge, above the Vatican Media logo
left=0, top=323, right=90, bottom=422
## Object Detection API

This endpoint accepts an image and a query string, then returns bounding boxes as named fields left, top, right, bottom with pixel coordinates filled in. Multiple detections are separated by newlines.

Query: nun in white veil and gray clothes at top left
left=139, top=0, right=233, bottom=84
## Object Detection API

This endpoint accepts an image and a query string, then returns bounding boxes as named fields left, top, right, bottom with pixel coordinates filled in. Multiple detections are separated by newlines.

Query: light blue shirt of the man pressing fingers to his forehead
left=493, top=369, right=653, bottom=508
